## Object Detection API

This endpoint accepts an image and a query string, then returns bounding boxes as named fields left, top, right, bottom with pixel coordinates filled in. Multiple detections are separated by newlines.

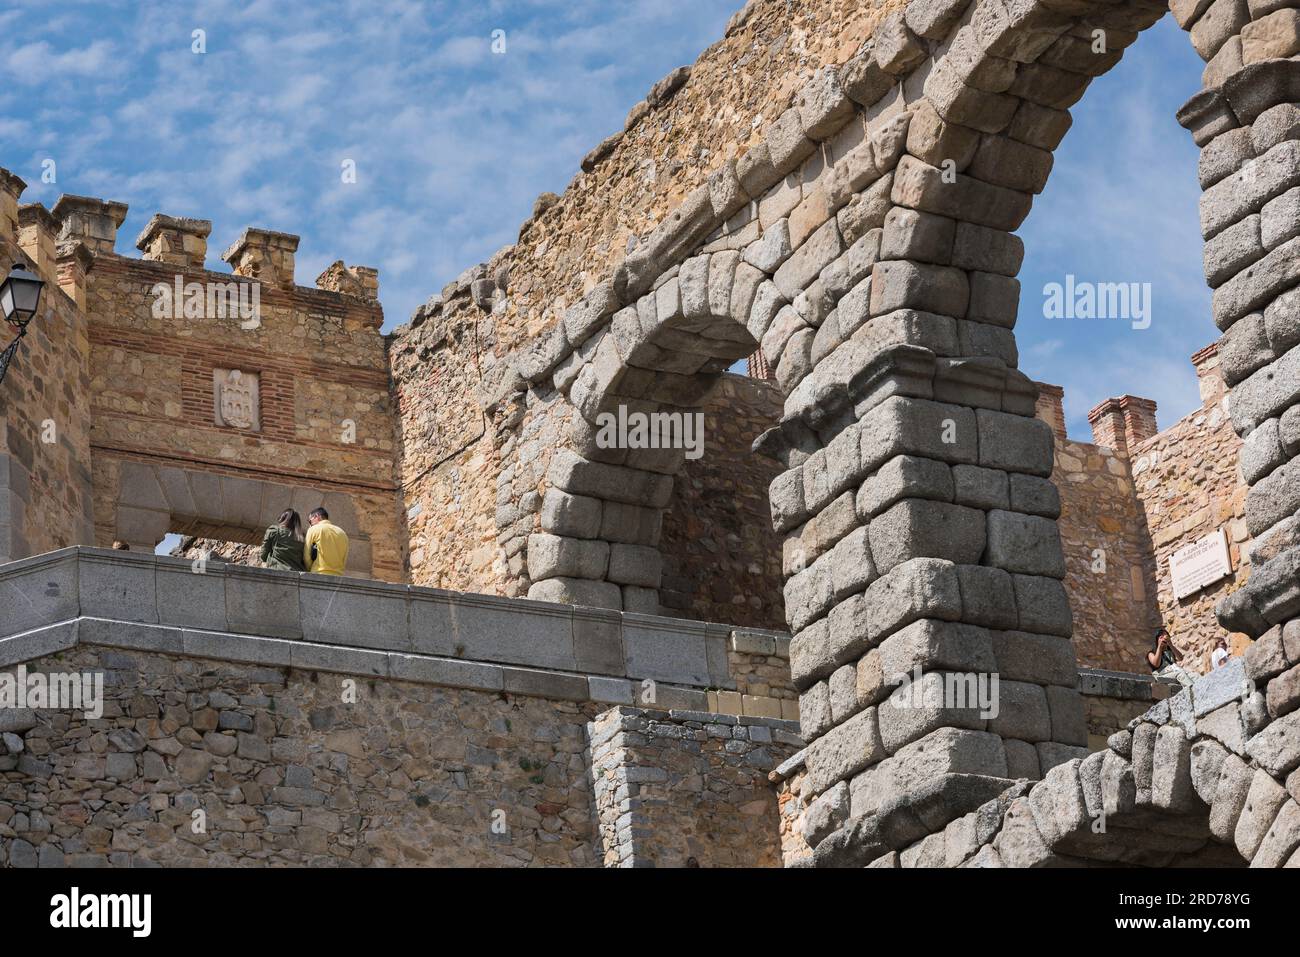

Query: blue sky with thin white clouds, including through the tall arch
left=0, top=0, right=1216, bottom=438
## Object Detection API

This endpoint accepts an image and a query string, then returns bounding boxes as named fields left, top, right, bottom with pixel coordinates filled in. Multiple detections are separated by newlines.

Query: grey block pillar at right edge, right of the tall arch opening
left=1178, top=57, right=1300, bottom=642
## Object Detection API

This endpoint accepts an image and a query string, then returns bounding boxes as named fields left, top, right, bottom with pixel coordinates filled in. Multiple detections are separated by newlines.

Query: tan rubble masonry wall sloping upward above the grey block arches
left=391, top=0, right=898, bottom=613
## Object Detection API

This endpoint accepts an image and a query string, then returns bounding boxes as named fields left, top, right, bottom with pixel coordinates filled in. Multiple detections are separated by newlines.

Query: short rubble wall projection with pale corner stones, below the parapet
left=590, top=707, right=803, bottom=867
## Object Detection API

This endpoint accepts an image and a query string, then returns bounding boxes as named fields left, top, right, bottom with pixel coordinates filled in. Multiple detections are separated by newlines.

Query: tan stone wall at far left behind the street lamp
left=0, top=230, right=94, bottom=562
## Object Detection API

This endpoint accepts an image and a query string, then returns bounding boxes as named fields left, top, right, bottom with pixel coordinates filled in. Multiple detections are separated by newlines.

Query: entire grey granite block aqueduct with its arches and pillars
left=488, top=0, right=1300, bottom=866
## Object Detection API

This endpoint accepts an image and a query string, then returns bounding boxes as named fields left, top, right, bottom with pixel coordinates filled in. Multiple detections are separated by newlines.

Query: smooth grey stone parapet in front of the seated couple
left=0, top=549, right=793, bottom=718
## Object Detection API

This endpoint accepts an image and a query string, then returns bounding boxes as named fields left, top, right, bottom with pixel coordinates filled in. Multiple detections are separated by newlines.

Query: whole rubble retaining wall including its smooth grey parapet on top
left=0, top=549, right=802, bottom=867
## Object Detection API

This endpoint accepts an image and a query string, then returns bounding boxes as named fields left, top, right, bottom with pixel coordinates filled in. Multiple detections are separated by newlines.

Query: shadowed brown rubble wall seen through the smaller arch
left=659, top=376, right=785, bottom=629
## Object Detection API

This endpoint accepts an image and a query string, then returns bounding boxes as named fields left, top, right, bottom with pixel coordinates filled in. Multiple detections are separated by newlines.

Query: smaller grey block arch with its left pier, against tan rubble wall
left=528, top=251, right=764, bottom=614
